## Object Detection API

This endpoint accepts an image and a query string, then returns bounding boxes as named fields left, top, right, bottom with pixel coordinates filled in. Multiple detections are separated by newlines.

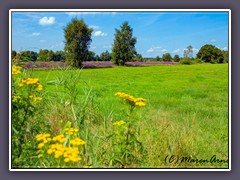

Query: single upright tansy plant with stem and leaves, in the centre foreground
left=106, top=92, right=146, bottom=167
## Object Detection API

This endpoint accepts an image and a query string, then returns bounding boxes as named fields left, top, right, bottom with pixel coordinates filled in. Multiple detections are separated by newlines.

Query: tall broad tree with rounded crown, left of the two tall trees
left=64, top=18, right=93, bottom=67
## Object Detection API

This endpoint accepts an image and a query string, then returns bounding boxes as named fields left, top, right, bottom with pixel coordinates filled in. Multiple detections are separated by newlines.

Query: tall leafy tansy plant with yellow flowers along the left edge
left=11, top=65, right=43, bottom=166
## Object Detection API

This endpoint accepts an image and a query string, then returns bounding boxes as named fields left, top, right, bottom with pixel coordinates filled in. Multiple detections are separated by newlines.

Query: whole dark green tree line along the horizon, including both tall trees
left=12, top=18, right=228, bottom=67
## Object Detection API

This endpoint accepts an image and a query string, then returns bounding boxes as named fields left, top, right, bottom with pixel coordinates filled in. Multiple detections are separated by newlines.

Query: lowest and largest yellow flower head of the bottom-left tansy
left=47, top=144, right=81, bottom=162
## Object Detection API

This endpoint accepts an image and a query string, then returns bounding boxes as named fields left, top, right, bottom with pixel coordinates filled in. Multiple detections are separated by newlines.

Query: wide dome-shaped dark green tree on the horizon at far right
left=197, top=44, right=224, bottom=63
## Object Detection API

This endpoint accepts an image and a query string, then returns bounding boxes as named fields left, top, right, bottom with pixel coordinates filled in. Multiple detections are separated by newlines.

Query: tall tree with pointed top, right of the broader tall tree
left=112, top=22, right=137, bottom=65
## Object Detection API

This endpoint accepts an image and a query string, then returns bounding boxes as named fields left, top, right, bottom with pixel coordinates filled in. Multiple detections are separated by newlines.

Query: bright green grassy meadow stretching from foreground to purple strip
left=11, top=64, right=229, bottom=168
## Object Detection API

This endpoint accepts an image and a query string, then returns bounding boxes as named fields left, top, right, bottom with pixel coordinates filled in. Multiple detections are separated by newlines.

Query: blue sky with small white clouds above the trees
left=12, top=12, right=228, bottom=57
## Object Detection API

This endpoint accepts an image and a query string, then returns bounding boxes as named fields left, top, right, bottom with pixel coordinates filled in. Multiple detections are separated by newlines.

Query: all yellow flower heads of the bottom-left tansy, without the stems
left=36, top=128, right=86, bottom=163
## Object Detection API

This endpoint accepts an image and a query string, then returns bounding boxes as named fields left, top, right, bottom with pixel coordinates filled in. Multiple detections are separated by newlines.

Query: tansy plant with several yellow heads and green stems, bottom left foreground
left=36, top=128, right=86, bottom=168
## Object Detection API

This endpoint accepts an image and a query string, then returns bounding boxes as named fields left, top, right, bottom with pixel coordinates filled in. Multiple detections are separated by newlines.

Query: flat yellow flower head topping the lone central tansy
left=115, top=92, right=146, bottom=106
